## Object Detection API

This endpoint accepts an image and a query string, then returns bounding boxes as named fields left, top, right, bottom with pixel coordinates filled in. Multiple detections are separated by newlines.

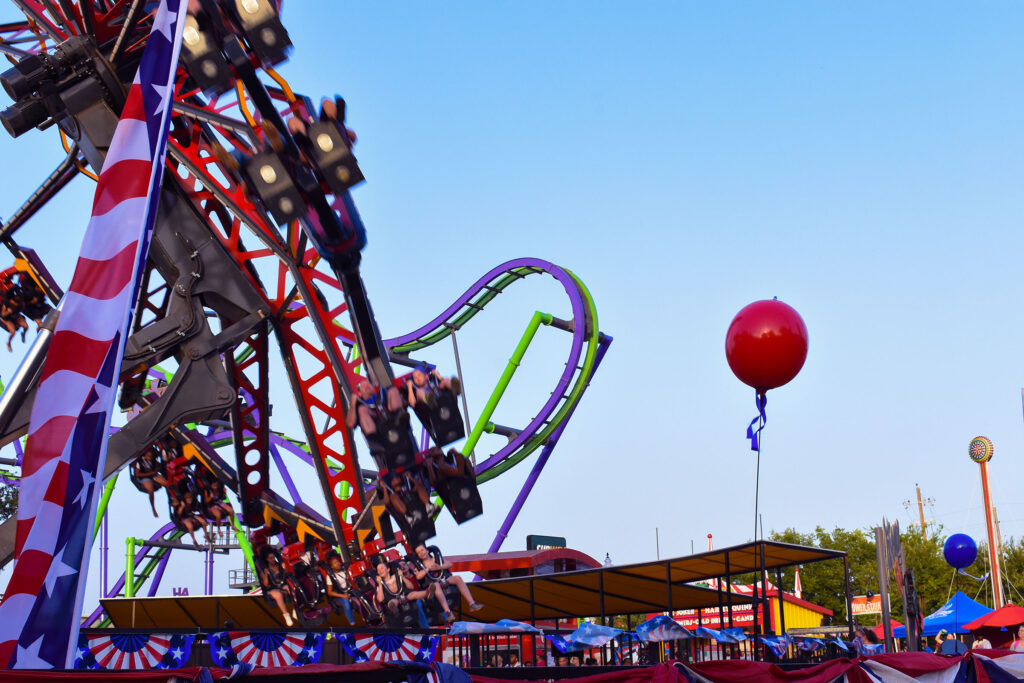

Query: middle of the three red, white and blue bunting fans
left=207, top=631, right=326, bottom=669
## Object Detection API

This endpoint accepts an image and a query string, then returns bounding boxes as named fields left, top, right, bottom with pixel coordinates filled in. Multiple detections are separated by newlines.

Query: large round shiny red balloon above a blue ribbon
left=725, top=299, right=807, bottom=393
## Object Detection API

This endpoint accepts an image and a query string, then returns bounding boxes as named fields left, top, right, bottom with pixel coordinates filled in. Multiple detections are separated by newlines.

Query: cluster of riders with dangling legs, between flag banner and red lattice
left=131, top=435, right=234, bottom=545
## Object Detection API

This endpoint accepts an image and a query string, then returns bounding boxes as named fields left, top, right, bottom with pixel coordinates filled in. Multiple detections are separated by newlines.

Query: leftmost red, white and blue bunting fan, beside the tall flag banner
left=75, top=633, right=196, bottom=671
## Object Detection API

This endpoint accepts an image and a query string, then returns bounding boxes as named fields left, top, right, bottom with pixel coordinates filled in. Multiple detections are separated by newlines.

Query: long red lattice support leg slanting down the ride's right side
left=168, top=79, right=372, bottom=544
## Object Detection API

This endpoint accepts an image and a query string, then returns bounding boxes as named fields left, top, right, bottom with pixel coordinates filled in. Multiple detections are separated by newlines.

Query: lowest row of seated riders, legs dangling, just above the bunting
left=256, top=540, right=483, bottom=628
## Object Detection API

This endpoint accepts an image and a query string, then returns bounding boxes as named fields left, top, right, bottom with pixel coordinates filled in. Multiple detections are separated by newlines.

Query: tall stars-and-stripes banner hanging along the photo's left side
left=0, top=0, right=187, bottom=669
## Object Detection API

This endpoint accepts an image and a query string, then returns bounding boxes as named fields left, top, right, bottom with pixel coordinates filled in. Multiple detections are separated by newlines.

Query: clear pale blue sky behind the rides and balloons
left=0, top=0, right=1024, bottom=591
